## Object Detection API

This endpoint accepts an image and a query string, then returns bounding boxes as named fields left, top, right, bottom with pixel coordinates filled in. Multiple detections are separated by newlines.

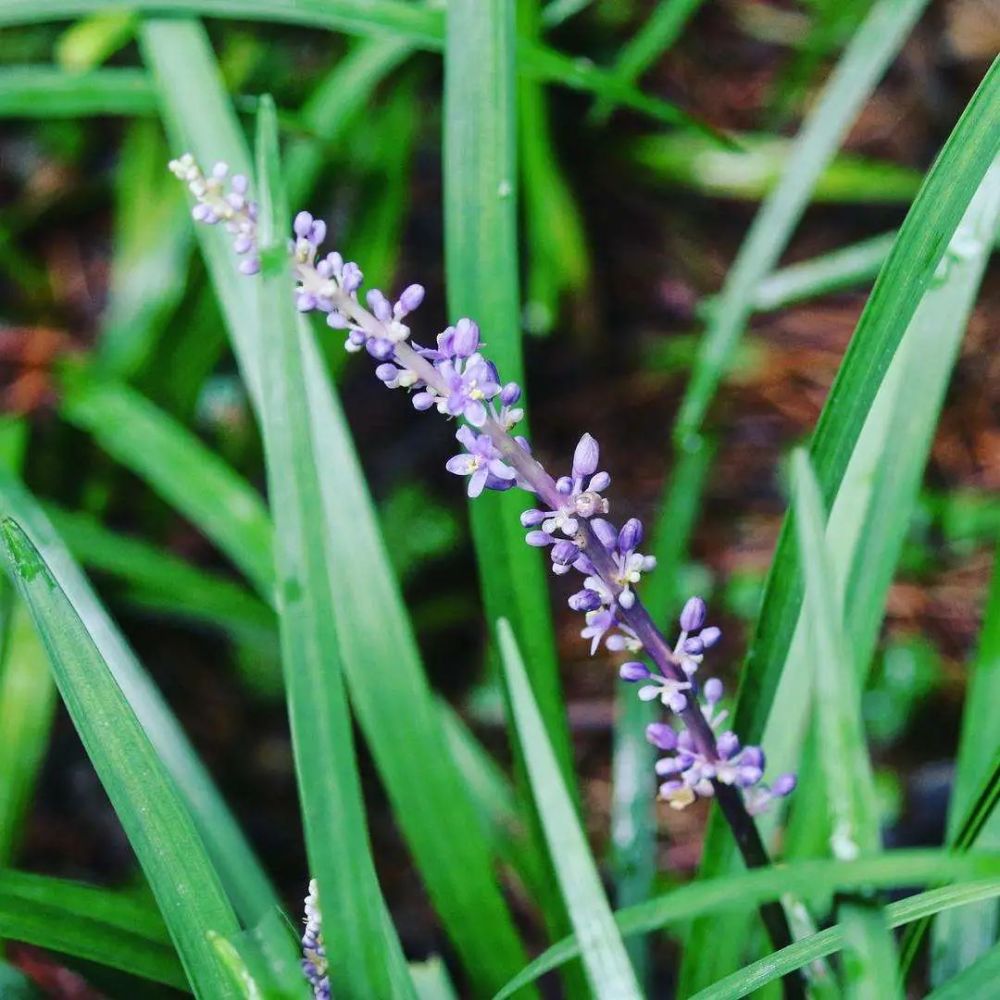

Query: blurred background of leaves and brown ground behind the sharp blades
left=0, top=0, right=1000, bottom=996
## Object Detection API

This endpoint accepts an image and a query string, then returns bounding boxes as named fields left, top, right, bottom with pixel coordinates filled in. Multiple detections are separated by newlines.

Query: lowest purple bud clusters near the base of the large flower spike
left=620, top=597, right=795, bottom=815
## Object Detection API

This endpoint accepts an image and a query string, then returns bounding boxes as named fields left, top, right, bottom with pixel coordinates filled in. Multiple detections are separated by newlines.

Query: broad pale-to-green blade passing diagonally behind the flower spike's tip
left=143, top=22, right=536, bottom=989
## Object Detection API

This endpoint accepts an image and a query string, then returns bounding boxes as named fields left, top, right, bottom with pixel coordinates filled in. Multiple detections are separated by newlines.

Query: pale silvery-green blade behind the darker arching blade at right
left=699, top=119, right=1000, bottom=992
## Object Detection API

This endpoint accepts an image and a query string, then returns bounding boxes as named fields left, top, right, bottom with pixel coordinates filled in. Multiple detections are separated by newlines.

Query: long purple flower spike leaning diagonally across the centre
left=170, top=154, right=795, bottom=828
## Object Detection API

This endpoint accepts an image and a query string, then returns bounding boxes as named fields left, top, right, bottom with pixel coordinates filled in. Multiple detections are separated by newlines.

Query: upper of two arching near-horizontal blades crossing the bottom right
left=495, top=850, right=1000, bottom=1000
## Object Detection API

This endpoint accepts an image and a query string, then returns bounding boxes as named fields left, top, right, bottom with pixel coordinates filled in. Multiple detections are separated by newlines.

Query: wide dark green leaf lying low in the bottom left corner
left=0, top=871, right=187, bottom=997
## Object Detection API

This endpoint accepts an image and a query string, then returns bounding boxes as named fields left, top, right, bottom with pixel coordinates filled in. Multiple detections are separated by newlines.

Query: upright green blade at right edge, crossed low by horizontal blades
left=931, top=550, right=1000, bottom=984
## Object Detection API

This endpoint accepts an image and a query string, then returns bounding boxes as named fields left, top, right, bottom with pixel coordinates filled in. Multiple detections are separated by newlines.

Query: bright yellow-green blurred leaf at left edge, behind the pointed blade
left=0, top=592, right=56, bottom=868
